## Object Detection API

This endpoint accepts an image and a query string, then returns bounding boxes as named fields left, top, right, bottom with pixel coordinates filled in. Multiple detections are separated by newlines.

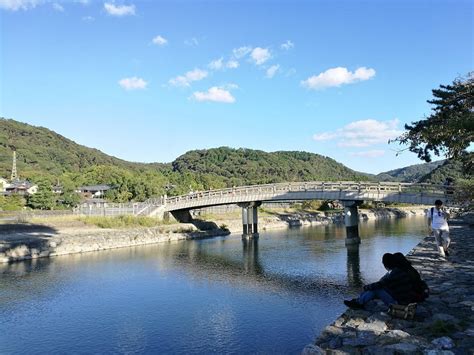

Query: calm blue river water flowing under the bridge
left=0, top=218, right=426, bottom=354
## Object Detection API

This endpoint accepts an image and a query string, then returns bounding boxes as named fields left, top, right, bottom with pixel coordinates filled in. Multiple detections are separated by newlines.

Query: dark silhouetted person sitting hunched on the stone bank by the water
left=344, top=253, right=414, bottom=308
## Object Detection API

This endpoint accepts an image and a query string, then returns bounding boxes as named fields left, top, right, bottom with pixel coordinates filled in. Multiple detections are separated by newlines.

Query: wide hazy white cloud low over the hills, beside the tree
left=313, top=119, right=403, bottom=147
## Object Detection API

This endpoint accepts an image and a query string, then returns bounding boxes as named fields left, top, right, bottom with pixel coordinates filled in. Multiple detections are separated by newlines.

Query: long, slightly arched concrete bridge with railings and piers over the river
left=160, top=181, right=453, bottom=244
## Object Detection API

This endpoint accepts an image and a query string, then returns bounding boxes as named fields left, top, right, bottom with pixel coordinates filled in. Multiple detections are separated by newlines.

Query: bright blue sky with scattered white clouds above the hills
left=0, top=0, right=474, bottom=173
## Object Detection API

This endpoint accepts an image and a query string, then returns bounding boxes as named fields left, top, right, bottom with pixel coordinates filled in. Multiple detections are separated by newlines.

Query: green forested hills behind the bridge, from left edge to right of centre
left=0, top=118, right=369, bottom=202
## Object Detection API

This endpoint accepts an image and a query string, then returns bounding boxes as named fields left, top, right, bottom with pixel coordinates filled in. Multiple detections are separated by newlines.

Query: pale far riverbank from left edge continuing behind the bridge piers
left=0, top=206, right=425, bottom=263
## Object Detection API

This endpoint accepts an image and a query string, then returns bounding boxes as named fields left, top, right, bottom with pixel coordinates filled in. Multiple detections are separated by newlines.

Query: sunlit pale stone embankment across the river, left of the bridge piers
left=0, top=224, right=229, bottom=263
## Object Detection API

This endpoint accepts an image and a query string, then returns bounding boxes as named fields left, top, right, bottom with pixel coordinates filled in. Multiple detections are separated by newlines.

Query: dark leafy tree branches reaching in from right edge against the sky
left=394, top=72, right=474, bottom=162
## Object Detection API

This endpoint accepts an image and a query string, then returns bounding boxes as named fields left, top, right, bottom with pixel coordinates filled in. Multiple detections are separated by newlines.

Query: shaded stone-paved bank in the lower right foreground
left=303, top=216, right=474, bottom=355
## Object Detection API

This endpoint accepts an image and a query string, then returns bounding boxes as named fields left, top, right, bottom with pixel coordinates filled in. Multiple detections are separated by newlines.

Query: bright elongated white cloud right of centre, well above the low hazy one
left=301, top=67, right=375, bottom=90
